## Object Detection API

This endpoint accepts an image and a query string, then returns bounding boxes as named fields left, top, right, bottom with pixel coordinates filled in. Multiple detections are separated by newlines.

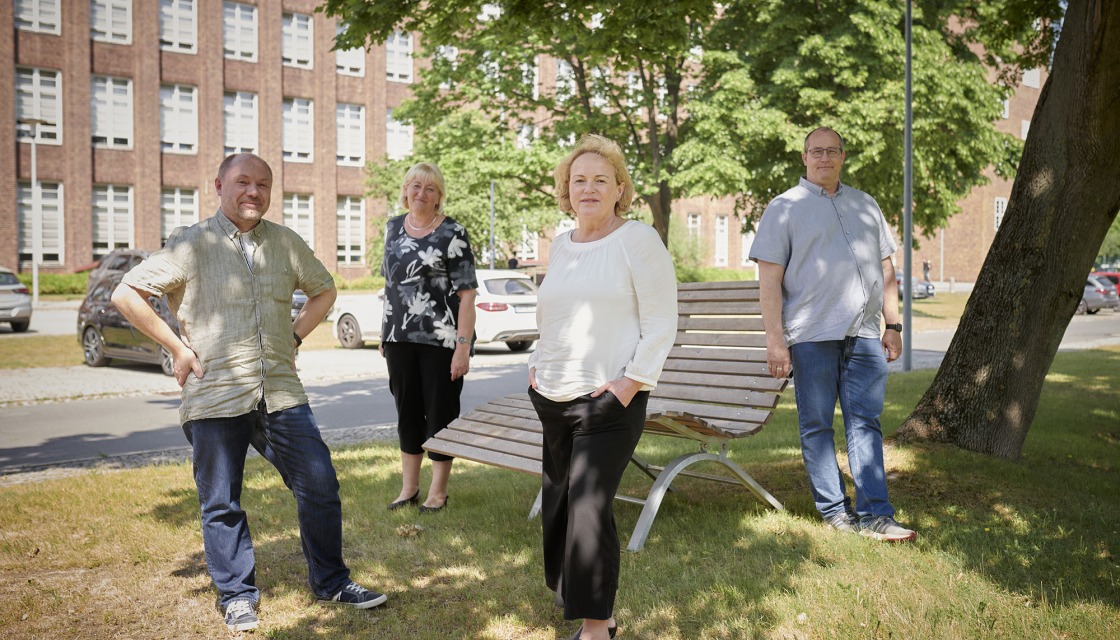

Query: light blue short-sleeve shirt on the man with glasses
left=750, top=177, right=898, bottom=345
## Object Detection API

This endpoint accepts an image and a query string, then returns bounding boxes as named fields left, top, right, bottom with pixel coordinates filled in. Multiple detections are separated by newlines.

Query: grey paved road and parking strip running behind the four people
left=0, top=298, right=1120, bottom=474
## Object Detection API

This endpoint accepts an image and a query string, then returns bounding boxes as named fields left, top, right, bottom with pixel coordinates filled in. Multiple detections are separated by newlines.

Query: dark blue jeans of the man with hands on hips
left=183, top=401, right=349, bottom=607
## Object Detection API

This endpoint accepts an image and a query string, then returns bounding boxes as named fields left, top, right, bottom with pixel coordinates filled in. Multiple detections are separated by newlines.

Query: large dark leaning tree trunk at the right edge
left=897, top=0, right=1120, bottom=460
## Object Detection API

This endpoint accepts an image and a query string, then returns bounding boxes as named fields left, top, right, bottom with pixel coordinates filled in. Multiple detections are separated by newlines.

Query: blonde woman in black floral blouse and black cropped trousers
left=381, top=163, right=478, bottom=512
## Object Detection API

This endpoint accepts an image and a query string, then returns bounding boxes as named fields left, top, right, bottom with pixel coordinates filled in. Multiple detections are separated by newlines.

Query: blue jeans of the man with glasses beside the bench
left=790, top=337, right=895, bottom=519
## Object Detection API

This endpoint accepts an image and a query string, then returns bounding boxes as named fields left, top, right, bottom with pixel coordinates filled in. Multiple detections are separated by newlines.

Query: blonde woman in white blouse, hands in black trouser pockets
left=529, top=136, right=676, bottom=640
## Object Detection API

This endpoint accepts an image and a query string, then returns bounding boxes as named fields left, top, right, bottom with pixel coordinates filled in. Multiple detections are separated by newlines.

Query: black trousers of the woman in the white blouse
left=529, top=389, right=650, bottom=620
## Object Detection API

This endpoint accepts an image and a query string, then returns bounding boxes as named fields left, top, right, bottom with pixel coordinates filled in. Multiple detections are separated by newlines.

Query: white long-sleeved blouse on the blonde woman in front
left=529, top=221, right=676, bottom=402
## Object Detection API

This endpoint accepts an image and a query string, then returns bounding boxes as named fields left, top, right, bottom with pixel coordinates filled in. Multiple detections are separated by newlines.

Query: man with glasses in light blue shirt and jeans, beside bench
left=750, top=127, right=917, bottom=541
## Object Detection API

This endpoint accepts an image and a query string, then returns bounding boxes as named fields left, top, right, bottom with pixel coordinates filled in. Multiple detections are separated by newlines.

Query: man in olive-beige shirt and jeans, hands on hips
left=112, top=154, right=385, bottom=632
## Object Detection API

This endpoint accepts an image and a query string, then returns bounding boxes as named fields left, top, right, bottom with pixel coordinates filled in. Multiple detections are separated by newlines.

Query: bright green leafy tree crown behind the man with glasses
left=674, top=0, right=1043, bottom=234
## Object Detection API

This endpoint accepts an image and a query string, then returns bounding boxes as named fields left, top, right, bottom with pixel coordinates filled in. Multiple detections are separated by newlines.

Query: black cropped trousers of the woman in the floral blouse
left=384, top=342, right=463, bottom=462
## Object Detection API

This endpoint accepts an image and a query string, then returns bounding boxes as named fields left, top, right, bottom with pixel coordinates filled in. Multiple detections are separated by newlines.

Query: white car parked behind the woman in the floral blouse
left=329, top=269, right=540, bottom=351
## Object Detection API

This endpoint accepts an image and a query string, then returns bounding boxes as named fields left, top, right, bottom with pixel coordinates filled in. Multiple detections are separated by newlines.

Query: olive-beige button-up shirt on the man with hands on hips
left=122, top=211, right=335, bottom=423
